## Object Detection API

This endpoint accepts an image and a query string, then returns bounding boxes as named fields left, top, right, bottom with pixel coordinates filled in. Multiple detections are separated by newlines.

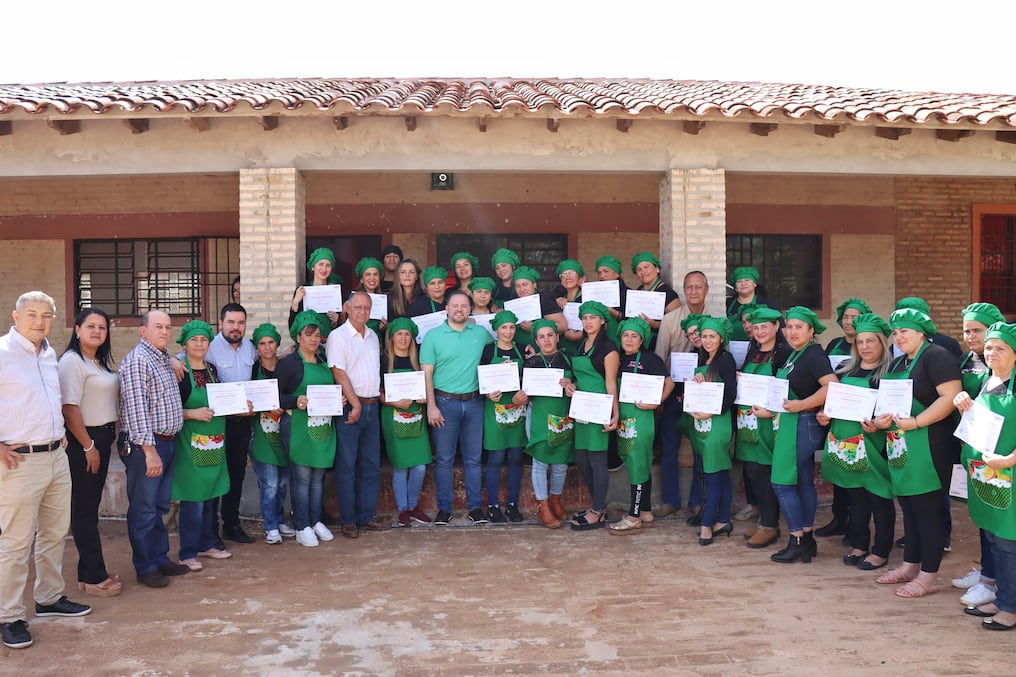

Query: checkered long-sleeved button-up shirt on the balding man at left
left=119, top=339, right=184, bottom=446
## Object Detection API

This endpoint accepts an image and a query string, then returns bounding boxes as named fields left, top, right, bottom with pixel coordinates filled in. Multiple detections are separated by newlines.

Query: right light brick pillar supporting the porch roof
left=659, top=169, right=726, bottom=316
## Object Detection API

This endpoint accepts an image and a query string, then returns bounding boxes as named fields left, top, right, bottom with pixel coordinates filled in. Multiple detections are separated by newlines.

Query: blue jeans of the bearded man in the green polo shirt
left=433, top=395, right=484, bottom=512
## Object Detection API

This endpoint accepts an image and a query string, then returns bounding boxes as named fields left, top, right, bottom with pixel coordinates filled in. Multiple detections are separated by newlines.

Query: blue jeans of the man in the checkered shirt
left=124, top=439, right=176, bottom=574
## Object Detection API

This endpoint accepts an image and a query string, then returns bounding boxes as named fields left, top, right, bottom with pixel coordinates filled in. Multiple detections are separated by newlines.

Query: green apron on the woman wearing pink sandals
left=882, top=341, right=942, bottom=496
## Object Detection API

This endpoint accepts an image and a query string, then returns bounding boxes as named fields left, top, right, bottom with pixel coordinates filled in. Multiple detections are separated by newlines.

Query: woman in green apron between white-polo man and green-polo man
left=381, top=317, right=434, bottom=527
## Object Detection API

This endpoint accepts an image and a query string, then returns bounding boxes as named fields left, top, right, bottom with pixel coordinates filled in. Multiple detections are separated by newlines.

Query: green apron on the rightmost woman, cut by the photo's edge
left=963, top=377, right=1016, bottom=541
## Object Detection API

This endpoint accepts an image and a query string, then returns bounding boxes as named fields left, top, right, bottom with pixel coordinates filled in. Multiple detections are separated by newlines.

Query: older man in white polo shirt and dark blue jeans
left=325, top=292, right=391, bottom=539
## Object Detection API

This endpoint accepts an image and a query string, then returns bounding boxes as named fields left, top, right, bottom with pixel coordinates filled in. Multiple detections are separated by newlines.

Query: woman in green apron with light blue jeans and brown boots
left=525, top=319, right=575, bottom=529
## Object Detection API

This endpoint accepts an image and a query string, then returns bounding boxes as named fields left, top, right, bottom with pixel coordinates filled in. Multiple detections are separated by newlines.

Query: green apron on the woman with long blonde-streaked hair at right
left=822, top=376, right=892, bottom=498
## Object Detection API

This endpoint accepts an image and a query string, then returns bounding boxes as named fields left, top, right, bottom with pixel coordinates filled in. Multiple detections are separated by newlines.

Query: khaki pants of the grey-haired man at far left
left=0, top=448, right=70, bottom=623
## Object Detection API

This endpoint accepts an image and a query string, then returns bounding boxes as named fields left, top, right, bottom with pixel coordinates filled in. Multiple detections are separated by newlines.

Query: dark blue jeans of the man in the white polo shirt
left=335, top=403, right=381, bottom=526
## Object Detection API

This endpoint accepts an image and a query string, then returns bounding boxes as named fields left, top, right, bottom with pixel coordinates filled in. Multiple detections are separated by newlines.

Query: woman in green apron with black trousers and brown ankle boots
left=734, top=306, right=791, bottom=548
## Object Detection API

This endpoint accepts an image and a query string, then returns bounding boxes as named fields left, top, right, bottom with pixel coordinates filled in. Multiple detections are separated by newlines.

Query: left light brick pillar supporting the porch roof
left=240, top=167, right=307, bottom=343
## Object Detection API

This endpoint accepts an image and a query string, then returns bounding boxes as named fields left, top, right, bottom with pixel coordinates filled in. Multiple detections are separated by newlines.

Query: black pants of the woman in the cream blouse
left=67, top=423, right=115, bottom=584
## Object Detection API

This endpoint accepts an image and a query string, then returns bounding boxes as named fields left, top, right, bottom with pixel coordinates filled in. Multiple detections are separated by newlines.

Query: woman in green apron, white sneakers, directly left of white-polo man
left=275, top=311, right=335, bottom=548
